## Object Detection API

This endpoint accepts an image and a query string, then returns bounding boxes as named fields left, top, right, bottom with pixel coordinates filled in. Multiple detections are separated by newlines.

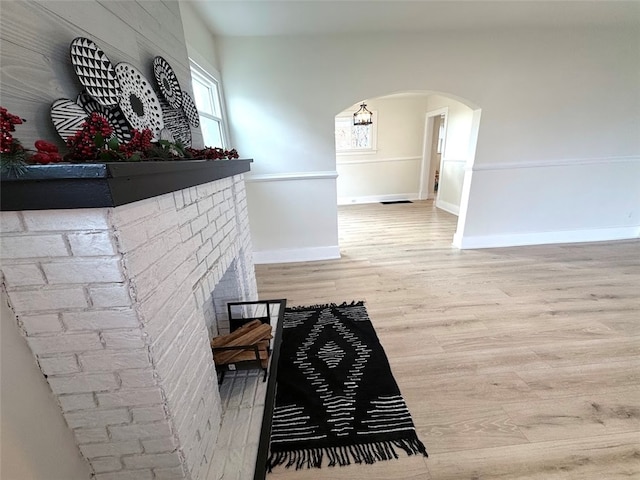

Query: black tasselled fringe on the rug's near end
left=267, top=437, right=429, bottom=473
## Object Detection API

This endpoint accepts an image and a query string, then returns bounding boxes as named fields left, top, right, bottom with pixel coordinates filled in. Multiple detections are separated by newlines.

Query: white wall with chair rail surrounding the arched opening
left=214, top=28, right=640, bottom=258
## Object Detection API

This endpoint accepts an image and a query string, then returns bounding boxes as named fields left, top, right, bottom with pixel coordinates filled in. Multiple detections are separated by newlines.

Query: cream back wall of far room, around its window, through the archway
left=336, top=94, right=428, bottom=205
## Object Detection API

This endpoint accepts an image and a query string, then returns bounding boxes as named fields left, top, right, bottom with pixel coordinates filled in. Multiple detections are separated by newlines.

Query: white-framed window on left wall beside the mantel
left=191, top=61, right=227, bottom=148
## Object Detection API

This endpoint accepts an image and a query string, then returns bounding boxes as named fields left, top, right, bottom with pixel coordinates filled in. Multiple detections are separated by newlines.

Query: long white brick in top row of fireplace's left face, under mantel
left=22, top=208, right=109, bottom=232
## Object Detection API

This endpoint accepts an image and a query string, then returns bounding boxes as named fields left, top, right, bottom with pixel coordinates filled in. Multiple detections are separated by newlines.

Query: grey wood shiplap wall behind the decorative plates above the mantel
left=0, top=0, right=202, bottom=152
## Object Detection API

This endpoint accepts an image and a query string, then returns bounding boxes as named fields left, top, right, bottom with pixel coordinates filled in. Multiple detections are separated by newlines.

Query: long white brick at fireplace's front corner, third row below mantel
left=42, top=258, right=124, bottom=284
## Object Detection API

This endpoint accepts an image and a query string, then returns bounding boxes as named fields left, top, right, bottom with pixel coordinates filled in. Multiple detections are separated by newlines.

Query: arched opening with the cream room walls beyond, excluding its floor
left=336, top=91, right=481, bottom=246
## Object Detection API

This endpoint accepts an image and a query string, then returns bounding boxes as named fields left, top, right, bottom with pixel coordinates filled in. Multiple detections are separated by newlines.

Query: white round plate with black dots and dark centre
left=115, top=62, right=164, bottom=140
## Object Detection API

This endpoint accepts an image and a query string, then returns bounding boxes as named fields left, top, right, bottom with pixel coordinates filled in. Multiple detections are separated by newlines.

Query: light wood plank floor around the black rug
left=256, top=201, right=640, bottom=480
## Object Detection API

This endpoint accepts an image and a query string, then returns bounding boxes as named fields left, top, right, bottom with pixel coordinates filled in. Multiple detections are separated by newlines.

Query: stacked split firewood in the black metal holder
left=211, top=320, right=273, bottom=368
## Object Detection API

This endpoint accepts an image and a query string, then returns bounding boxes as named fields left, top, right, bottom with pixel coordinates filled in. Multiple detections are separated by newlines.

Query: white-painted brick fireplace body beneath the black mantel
left=1, top=171, right=257, bottom=480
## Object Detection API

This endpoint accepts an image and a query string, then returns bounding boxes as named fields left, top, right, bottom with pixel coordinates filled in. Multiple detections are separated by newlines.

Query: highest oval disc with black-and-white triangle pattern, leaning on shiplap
left=71, top=37, right=122, bottom=107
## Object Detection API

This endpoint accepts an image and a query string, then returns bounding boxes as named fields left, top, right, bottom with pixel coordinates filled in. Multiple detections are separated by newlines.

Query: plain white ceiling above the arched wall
left=188, top=0, right=640, bottom=36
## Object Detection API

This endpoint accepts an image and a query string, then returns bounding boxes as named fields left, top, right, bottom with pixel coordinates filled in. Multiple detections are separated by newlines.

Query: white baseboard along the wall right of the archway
left=453, top=227, right=640, bottom=250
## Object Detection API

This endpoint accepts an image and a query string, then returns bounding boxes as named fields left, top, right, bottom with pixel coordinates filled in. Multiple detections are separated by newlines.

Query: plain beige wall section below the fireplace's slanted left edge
left=0, top=291, right=91, bottom=480
